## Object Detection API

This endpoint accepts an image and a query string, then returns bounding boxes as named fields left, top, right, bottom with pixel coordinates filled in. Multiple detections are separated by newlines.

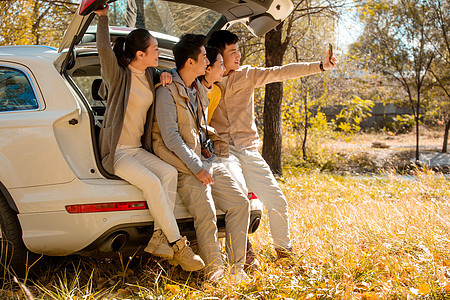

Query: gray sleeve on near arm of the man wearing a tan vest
left=155, top=86, right=204, bottom=174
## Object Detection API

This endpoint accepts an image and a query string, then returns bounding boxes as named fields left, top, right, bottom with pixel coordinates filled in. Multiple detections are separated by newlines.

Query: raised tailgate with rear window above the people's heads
left=55, top=0, right=293, bottom=72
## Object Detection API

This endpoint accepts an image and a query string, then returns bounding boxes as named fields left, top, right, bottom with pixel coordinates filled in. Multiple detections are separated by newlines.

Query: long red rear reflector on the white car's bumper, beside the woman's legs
left=66, top=201, right=148, bottom=214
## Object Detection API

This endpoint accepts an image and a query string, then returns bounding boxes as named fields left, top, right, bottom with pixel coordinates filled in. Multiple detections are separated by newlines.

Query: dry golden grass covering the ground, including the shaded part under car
left=0, top=172, right=450, bottom=300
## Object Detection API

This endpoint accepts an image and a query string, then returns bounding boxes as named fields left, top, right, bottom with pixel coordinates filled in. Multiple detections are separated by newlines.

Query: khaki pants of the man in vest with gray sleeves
left=178, top=158, right=250, bottom=273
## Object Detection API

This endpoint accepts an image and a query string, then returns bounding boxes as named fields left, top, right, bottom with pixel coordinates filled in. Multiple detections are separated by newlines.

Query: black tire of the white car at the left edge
left=0, top=193, right=28, bottom=278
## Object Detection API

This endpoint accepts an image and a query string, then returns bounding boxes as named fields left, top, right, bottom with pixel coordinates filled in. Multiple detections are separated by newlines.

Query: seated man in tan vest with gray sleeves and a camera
left=152, top=34, right=250, bottom=281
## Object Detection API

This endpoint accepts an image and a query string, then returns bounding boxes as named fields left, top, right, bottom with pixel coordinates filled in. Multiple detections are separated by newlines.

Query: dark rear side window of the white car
left=0, top=66, right=39, bottom=112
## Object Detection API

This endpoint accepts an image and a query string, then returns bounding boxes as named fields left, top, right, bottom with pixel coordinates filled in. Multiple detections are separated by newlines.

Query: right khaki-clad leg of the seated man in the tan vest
left=208, top=158, right=250, bottom=270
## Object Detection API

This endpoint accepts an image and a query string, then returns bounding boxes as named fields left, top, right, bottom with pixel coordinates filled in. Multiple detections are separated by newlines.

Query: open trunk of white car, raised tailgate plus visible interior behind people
left=54, top=0, right=293, bottom=178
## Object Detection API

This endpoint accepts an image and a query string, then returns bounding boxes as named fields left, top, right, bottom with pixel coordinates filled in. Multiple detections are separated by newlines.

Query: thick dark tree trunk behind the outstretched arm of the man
left=262, top=23, right=285, bottom=176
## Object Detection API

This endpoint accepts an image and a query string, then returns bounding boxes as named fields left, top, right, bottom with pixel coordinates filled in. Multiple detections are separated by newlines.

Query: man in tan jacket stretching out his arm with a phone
left=208, top=30, right=337, bottom=258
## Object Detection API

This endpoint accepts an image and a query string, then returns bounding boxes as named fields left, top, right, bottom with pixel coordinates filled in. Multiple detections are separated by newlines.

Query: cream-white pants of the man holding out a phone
left=222, top=145, right=291, bottom=249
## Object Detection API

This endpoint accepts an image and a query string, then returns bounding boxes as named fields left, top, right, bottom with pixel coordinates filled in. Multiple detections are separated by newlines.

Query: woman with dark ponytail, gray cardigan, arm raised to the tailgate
left=95, top=4, right=205, bottom=271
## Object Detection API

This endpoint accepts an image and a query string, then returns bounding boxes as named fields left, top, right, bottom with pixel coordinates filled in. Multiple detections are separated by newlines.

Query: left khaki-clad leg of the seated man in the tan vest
left=178, top=173, right=223, bottom=274
